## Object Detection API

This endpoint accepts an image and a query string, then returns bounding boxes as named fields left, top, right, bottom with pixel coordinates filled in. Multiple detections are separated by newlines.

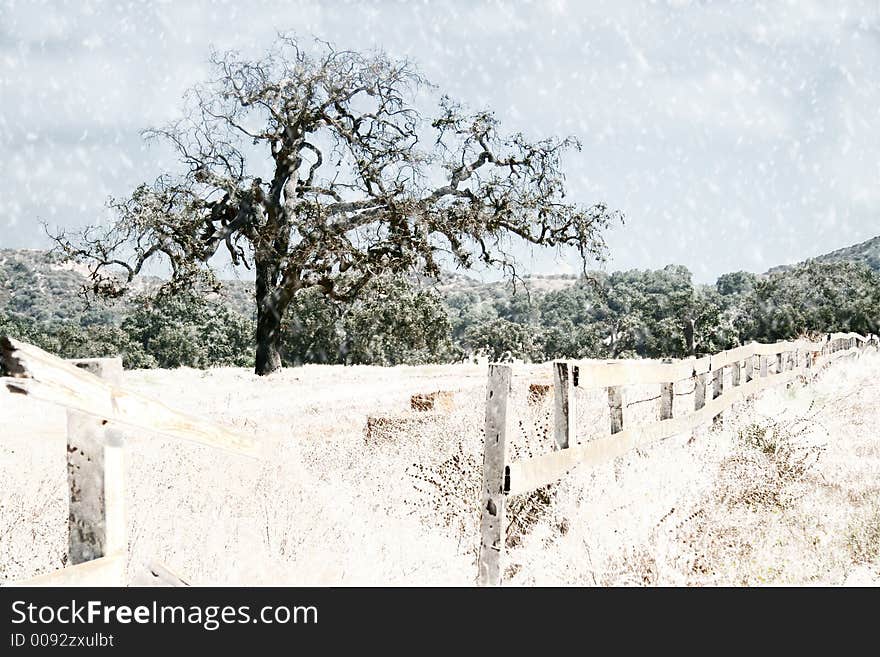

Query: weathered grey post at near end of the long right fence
left=477, top=363, right=511, bottom=586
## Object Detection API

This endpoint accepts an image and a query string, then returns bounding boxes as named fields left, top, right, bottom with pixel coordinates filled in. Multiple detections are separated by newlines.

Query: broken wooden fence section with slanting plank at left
left=0, top=337, right=257, bottom=586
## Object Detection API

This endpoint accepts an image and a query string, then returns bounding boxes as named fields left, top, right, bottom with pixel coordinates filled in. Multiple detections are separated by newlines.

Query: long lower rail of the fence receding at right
left=507, top=370, right=801, bottom=495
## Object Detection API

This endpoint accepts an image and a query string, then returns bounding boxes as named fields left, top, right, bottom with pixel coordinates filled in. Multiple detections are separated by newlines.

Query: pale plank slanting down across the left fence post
left=0, top=338, right=260, bottom=456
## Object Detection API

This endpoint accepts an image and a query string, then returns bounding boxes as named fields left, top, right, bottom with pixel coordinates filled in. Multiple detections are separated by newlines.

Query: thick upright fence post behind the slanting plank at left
left=67, top=358, right=126, bottom=583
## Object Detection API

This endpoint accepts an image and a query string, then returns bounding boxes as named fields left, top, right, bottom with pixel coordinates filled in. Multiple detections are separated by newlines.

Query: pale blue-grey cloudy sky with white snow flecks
left=0, top=0, right=880, bottom=282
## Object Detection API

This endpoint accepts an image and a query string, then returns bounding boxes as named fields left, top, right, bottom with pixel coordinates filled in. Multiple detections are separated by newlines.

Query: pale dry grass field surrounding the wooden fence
left=0, top=352, right=880, bottom=586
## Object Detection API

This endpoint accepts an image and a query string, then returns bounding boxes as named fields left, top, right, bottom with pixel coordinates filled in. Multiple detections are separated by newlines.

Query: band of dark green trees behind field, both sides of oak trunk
left=0, top=254, right=880, bottom=368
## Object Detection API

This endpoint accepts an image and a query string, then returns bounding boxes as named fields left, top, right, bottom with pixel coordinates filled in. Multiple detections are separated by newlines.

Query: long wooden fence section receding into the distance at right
left=477, top=333, right=878, bottom=586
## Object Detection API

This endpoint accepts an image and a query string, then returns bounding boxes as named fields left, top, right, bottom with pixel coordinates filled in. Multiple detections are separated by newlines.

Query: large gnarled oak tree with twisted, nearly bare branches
left=55, top=35, right=616, bottom=374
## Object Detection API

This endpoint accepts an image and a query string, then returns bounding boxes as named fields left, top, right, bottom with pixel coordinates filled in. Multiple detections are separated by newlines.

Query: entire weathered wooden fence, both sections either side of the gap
left=0, top=333, right=878, bottom=586
